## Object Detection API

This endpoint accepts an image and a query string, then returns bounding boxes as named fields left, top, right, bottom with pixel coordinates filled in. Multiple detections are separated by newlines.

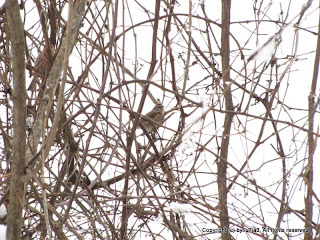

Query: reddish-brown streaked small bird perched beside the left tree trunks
left=28, top=44, right=55, bottom=92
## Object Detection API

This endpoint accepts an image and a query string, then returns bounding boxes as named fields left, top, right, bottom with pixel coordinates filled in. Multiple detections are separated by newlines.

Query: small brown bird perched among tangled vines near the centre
left=137, top=102, right=164, bottom=133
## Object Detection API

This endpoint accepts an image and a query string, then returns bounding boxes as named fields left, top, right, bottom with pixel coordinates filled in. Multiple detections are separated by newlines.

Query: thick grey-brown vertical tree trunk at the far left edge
left=6, top=0, right=27, bottom=240
